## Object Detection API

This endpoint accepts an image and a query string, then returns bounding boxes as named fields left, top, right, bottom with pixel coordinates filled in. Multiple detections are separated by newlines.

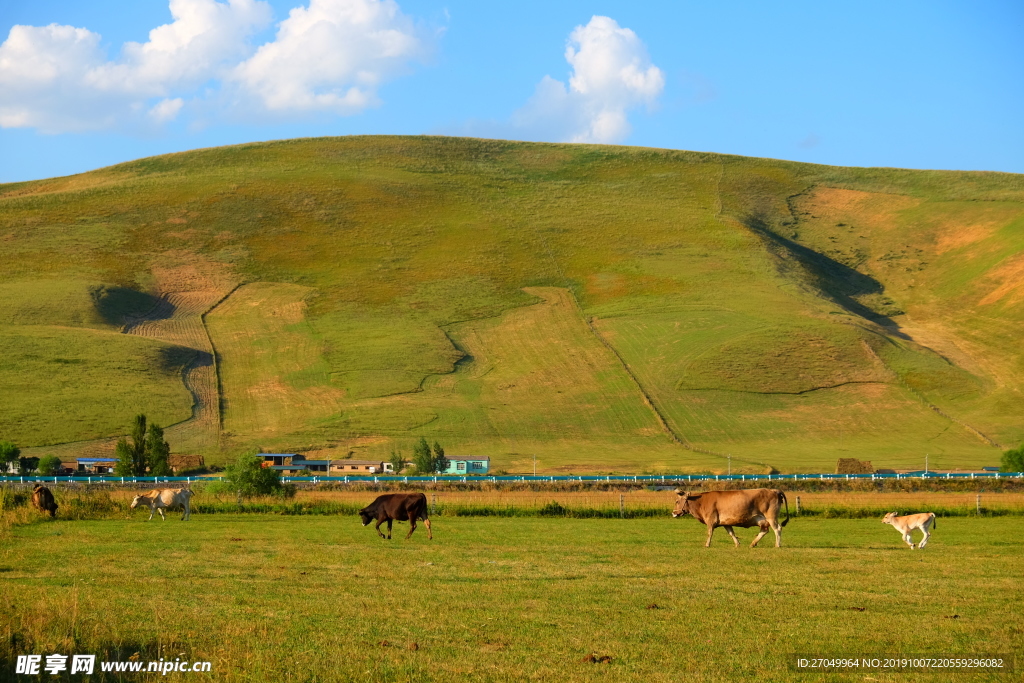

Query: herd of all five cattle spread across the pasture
left=25, top=485, right=936, bottom=550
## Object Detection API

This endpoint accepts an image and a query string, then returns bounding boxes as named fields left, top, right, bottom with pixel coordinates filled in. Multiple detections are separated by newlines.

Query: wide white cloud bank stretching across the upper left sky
left=0, top=0, right=426, bottom=133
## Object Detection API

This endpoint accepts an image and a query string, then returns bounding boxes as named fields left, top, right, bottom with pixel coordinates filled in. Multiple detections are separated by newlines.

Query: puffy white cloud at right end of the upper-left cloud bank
left=233, top=0, right=426, bottom=114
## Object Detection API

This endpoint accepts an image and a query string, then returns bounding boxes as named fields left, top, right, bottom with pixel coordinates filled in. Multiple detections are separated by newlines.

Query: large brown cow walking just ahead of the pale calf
left=672, top=488, right=790, bottom=548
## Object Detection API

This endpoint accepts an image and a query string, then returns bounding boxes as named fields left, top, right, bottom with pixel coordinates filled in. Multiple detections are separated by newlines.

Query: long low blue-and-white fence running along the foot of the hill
left=0, top=470, right=1024, bottom=484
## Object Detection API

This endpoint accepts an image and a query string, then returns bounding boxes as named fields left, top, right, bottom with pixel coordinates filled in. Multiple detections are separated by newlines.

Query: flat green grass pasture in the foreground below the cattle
left=0, top=513, right=1024, bottom=681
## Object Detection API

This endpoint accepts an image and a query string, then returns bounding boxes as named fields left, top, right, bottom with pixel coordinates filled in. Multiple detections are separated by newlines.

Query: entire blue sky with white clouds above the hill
left=0, top=0, right=1024, bottom=181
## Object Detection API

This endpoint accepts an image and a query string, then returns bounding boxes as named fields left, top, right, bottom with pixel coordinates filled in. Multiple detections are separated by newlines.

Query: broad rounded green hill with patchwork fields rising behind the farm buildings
left=0, top=137, right=1024, bottom=472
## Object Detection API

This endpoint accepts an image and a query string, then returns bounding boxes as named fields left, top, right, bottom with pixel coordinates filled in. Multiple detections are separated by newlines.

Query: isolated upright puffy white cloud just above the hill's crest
left=512, top=16, right=665, bottom=143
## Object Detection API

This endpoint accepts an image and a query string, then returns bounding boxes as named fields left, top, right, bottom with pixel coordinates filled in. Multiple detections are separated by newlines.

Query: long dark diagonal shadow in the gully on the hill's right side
left=743, top=215, right=910, bottom=340
